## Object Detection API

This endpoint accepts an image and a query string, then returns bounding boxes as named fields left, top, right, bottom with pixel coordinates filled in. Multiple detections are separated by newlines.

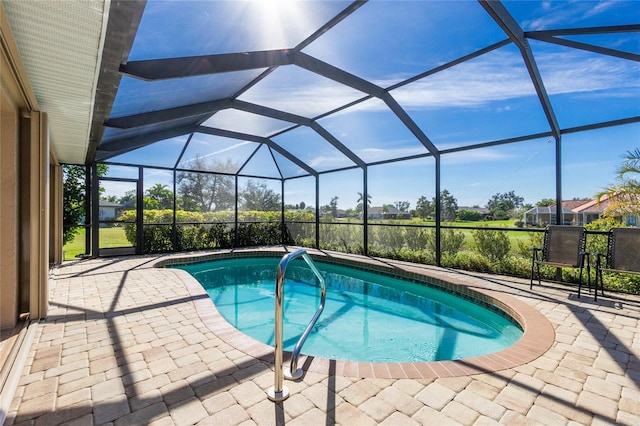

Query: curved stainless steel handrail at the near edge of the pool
left=267, top=249, right=327, bottom=402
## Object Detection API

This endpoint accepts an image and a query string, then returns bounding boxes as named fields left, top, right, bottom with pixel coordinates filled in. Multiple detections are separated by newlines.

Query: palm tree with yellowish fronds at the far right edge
left=598, top=148, right=640, bottom=217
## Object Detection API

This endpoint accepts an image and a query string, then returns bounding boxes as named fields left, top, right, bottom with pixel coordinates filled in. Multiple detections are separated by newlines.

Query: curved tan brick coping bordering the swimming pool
left=154, top=246, right=555, bottom=379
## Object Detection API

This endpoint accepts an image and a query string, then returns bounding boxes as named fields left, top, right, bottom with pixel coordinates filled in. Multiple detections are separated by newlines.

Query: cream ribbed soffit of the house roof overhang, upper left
left=3, top=0, right=109, bottom=164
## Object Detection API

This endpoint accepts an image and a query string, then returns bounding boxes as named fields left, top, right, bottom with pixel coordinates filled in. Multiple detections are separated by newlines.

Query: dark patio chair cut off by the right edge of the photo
left=592, top=228, right=640, bottom=300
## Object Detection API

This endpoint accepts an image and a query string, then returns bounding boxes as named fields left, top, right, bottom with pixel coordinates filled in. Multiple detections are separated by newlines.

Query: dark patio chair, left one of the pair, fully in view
left=529, top=225, right=591, bottom=297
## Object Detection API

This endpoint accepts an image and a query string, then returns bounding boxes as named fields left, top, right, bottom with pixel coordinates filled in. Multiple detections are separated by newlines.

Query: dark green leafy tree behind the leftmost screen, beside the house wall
left=62, top=164, right=109, bottom=244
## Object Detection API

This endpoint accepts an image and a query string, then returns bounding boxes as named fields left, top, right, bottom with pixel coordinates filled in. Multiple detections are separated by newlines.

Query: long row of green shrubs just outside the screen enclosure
left=125, top=210, right=640, bottom=293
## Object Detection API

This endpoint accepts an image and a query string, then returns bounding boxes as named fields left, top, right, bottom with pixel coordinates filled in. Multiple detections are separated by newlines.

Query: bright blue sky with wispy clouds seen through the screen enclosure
left=102, top=0, right=640, bottom=209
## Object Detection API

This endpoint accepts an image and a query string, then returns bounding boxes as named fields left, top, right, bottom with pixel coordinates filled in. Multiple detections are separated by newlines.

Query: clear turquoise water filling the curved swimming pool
left=177, top=257, right=522, bottom=362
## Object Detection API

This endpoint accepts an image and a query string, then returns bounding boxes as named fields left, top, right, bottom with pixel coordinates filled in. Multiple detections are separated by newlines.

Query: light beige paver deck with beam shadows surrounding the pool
left=5, top=248, right=640, bottom=425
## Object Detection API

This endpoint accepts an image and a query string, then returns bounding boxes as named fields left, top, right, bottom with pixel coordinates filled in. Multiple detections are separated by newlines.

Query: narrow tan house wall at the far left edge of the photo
left=0, top=84, right=19, bottom=329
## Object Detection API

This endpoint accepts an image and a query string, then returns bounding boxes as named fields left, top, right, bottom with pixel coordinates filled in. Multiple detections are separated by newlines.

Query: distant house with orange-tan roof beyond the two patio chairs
left=524, top=196, right=640, bottom=226
